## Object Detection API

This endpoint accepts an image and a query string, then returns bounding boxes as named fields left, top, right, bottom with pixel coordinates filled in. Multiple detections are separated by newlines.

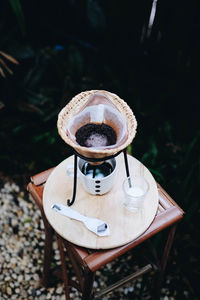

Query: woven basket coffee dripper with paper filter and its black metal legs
left=57, top=90, right=137, bottom=206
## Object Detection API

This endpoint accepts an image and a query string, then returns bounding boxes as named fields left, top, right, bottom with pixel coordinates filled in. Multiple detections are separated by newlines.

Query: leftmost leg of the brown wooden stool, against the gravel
left=42, top=225, right=53, bottom=287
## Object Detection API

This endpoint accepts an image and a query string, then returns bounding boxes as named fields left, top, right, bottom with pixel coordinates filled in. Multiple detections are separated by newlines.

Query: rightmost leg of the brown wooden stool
left=152, top=225, right=176, bottom=299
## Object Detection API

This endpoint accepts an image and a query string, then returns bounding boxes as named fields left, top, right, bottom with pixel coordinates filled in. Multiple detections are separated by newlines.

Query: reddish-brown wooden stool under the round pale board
left=27, top=168, right=183, bottom=300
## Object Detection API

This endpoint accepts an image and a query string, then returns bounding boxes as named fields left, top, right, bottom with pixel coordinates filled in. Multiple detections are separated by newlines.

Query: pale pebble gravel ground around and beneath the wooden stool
left=0, top=182, right=189, bottom=300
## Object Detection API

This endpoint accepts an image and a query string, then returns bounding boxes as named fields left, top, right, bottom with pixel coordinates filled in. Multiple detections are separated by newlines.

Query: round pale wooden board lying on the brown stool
left=43, top=154, right=158, bottom=249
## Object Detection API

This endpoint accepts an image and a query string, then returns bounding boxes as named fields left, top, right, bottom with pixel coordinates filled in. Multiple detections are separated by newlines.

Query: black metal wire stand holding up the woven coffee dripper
left=67, top=148, right=131, bottom=206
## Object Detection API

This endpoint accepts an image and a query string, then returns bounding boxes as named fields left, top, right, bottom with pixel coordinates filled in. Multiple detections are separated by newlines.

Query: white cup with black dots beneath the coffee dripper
left=66, top=158, right=116, bottom=195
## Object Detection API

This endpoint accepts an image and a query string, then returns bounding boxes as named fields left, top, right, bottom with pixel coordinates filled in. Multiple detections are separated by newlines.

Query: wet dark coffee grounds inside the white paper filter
left=75, top=123, right=117, bottom=147
